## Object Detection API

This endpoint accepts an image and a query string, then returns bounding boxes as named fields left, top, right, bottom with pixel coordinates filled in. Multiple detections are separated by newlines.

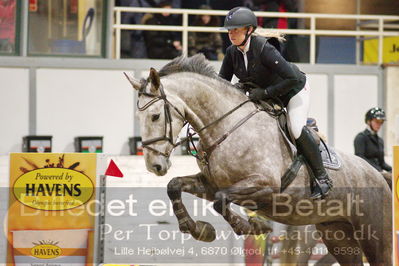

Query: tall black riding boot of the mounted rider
left=296, top=127, right=333, bottom=199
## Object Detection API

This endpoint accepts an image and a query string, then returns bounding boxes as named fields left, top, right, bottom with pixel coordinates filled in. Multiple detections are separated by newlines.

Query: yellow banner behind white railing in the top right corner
left=363, top=37, right=399, bottom=64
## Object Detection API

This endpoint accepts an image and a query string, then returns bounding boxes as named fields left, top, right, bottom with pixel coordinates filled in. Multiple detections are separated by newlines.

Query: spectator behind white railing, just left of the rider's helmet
left=188, top=5, right=223, bottom=60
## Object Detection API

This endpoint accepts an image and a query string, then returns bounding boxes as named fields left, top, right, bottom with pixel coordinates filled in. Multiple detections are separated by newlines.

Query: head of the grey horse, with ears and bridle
left=125, top=68, right=184, bottom=176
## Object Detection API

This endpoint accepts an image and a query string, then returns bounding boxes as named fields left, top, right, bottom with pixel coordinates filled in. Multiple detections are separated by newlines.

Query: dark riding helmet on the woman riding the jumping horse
left=223, top=6, right=258, bottom=30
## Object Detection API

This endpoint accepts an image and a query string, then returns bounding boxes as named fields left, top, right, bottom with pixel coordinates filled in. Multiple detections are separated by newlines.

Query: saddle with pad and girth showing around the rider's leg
left=260, top=100, right=341, bottom=192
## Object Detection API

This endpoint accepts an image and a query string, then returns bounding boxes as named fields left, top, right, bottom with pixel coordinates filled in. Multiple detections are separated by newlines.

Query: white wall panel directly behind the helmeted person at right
left=334, top=75, right=378, bottom=154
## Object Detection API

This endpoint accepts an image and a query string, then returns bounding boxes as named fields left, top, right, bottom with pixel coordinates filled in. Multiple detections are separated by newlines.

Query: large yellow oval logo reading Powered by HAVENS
left=14, top=168, right=94, bottom=211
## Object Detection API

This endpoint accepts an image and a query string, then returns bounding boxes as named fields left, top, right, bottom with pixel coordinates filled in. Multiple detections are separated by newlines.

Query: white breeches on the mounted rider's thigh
left=287, top=82, right=310, bottom=139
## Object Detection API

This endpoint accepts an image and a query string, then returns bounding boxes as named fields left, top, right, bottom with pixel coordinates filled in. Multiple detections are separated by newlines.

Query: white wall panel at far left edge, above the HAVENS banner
left=0, top=68, right=29, bottom=154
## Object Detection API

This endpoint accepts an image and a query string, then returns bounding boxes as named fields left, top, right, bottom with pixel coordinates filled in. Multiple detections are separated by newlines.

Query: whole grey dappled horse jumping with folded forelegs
left=127, top=56, right=392, bottom=265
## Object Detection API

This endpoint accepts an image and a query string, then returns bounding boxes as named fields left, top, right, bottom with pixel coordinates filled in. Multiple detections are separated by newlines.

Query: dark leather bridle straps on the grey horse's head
left=137, top=79, right=187, bottom=158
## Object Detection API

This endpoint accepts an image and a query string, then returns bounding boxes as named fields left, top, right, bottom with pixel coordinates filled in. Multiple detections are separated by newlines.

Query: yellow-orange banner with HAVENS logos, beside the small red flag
left=7, top=153, right=97, bottom=266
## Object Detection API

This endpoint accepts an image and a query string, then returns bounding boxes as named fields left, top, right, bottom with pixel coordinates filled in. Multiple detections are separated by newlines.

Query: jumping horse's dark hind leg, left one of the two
left=316, top=222, right=363, bottom=266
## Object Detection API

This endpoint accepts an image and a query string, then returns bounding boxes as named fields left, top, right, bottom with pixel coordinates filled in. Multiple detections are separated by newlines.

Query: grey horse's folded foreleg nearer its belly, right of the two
left=213, top=176, right=273, bottom=235
